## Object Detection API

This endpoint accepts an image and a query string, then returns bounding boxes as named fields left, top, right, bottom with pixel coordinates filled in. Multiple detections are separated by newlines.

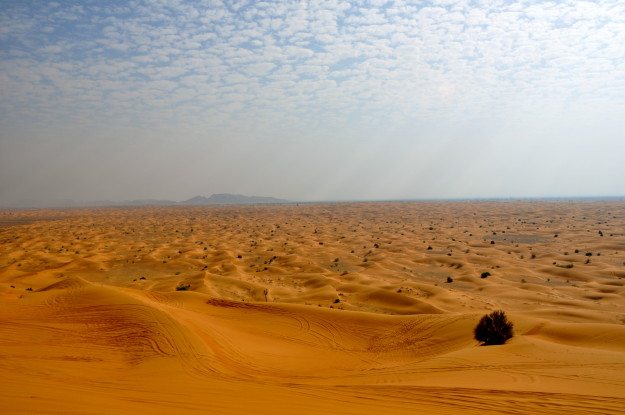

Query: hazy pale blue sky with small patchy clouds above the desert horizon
left=0, top=0, right=625, bottom=205
